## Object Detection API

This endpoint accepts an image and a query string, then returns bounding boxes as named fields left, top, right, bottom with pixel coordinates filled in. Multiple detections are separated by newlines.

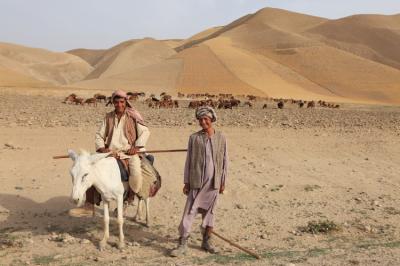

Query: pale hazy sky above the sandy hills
left=0, top=0, right=400, bottom=51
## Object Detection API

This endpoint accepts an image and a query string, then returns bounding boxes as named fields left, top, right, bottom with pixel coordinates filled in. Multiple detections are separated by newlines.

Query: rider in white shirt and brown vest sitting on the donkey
left=69, top=90, right=151, bottom=217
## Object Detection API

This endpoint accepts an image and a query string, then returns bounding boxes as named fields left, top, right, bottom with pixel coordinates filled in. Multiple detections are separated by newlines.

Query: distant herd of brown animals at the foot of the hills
left=63, top=92, right=340, bottom=109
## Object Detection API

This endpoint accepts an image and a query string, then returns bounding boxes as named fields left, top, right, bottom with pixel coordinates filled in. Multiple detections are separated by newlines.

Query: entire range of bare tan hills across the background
left=0, top=8, right=400, bottom=104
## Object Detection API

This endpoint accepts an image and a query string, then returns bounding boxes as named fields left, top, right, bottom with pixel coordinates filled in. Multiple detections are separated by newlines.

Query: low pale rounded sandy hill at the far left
left=0, top=43, right=92, bottom=85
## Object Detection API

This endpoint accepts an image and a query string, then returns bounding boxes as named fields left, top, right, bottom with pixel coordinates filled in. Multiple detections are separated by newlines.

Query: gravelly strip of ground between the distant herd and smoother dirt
left=0, top=93, right=400, bottom=132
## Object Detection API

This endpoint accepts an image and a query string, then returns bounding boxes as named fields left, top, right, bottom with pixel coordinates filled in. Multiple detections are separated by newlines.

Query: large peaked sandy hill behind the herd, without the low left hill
left=63, top=8, right=400, bottom=103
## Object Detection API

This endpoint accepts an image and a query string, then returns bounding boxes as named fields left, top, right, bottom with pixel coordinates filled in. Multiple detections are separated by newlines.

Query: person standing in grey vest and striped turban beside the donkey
left=171, top=106, right=228, bottom=257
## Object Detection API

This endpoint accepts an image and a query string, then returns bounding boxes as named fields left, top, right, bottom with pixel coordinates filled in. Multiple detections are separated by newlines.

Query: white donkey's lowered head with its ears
left=68, top=150, right=109, bottom=207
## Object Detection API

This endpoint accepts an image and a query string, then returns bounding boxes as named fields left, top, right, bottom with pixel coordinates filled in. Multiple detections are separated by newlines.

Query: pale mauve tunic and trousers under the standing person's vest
left=179, top=136, right=228, bottom=237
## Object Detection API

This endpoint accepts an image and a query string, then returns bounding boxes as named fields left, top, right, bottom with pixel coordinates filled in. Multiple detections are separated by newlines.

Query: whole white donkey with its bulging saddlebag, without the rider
left=68, top=150, right=161, bottom=250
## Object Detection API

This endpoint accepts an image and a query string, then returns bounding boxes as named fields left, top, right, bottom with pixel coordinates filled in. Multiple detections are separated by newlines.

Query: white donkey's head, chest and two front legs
left=68, top=150, right=125, bottom=250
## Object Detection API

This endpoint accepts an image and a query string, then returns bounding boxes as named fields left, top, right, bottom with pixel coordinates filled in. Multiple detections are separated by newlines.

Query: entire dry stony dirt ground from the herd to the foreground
left=0, top=92, right=400, bottom=265
